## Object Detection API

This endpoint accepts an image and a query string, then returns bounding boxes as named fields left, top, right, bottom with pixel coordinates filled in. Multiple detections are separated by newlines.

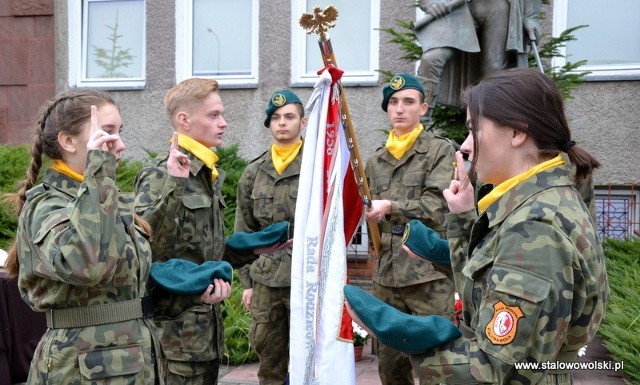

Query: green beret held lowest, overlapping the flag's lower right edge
left=344, top=285, right=461, bottom=354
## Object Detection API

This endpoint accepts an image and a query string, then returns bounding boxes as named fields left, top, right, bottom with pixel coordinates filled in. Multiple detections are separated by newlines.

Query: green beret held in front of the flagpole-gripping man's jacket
left=402, top=219, right=451, bottom=266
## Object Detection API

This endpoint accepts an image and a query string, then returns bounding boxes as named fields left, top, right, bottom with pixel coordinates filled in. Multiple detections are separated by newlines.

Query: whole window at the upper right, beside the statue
left=553, top=0, right=640, bottom=80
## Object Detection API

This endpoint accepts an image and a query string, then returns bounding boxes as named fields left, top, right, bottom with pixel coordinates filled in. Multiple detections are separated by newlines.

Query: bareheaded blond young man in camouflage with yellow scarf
left=135, top=78, right=231, bottom=385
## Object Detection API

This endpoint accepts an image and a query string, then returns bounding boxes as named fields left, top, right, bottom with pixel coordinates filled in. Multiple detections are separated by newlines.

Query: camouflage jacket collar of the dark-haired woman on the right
left=485, top=164, right=582, bottom=227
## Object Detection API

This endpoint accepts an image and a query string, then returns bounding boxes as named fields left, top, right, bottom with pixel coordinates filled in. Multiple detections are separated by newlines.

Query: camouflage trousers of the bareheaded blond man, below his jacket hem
left=163, top=359, right=220, bottom=385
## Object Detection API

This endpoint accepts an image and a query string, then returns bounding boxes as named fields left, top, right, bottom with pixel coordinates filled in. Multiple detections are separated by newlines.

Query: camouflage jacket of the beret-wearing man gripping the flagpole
left=366, top=130, right=455, bottom=287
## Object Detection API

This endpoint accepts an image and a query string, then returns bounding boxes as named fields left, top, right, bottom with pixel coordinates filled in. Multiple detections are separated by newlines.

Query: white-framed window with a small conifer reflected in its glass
left=68, top=0, right=146, bottom=89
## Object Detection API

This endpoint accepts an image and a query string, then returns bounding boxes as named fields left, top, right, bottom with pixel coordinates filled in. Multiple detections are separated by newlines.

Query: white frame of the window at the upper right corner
left=551, top=0, right=640, bottom=81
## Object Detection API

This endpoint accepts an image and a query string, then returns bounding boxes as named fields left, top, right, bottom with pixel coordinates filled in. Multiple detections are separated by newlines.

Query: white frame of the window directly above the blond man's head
left=175, top=0, right=260, bottom=88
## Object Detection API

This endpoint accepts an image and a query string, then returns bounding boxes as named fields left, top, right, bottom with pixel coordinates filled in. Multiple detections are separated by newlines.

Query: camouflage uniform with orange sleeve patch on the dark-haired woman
left=412, top=166, right=609, bottom=384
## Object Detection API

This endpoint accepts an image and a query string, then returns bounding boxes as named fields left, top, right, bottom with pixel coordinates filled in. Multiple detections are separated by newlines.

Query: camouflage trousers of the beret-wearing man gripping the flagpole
left=373, top=278, right=455, bottom=385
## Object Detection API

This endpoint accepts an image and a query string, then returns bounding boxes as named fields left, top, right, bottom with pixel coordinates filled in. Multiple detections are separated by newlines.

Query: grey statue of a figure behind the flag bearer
left=416, top=0, right=541, bottom=117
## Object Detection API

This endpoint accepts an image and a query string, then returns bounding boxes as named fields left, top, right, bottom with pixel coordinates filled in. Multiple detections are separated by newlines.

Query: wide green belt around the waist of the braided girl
left=46, top=296, right=153, bottom=329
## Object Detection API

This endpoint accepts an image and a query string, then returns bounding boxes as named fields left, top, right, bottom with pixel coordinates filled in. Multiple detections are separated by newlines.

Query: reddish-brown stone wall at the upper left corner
left=0, top=0, right=55, bottom=144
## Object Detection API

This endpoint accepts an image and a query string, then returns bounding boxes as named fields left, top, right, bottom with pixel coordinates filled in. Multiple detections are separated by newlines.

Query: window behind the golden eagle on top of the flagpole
left=291, top=0, right=380, bottom=86
